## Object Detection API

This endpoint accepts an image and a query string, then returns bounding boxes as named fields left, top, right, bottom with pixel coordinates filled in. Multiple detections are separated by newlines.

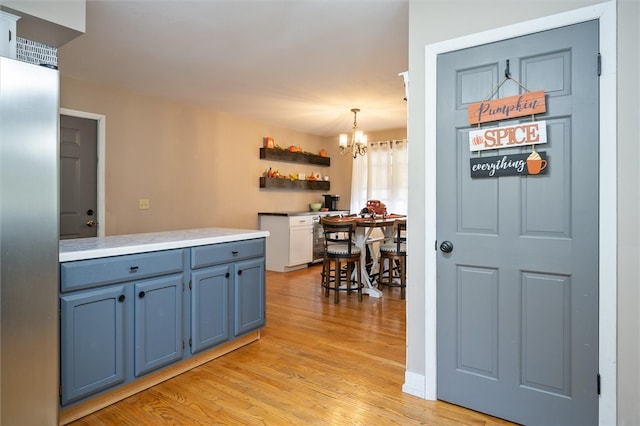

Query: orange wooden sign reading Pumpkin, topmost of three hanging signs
left=467, top=90, right=547, bottom=124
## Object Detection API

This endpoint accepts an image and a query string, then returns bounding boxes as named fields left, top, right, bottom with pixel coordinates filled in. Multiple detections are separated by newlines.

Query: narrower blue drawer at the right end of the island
left=191, top=238, right=264, bottom=269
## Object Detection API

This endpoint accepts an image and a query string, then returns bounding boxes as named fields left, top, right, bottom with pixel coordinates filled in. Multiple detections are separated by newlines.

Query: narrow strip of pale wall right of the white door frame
left=616, top=0, right=640, bottom=425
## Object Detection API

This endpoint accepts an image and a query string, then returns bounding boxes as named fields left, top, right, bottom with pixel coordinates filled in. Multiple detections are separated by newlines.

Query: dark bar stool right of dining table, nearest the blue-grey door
left=378, top=219, right=407, bottom=300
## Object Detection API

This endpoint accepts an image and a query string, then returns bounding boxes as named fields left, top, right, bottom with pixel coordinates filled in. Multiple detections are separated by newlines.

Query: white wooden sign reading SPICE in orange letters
left=469, top=121, right=547, bottom=151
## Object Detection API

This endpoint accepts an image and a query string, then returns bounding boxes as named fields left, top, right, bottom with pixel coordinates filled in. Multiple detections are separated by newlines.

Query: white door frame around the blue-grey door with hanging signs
left=424, top=0, right=617, bottom=424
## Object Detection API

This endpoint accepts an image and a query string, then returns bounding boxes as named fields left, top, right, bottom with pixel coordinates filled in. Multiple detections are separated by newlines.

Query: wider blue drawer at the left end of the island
left=60, top=250, right=184, bottom=292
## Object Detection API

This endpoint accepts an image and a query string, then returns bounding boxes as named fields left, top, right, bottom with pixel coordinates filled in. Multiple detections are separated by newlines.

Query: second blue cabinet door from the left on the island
left=134, top=275, right=182, bottom=377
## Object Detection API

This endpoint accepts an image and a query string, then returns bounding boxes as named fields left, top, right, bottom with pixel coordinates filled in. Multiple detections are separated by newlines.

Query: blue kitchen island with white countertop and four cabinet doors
left=59, top=228, right=269, bottom=424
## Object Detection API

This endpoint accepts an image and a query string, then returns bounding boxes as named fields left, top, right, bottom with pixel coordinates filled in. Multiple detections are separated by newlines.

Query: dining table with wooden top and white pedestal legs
left=353, top=213, right=407, bottom=297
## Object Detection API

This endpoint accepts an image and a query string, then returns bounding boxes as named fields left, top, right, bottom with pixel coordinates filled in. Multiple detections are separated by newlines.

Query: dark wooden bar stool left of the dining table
left=320, top=217, right=363, bottom=303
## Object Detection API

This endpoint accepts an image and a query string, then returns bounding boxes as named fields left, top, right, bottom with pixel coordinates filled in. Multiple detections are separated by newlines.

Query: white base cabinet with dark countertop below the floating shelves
left=260, top=214, right=313, bottom=272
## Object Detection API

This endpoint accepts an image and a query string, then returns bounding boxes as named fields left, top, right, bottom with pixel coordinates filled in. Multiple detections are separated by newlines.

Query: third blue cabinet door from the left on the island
left=191, top=265, right=231, bottom=353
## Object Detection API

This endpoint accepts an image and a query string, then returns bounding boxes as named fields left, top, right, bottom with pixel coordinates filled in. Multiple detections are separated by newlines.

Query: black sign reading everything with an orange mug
left=469, top=151, right=549, bottom=178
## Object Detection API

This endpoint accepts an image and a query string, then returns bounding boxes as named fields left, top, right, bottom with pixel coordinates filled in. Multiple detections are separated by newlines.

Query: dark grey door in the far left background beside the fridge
left=60, top=115, right=98, bottom=239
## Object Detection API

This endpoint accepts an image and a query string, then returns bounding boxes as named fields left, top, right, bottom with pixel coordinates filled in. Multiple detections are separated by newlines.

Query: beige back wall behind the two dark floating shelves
left=60, top=75, right=360, bottom=235
